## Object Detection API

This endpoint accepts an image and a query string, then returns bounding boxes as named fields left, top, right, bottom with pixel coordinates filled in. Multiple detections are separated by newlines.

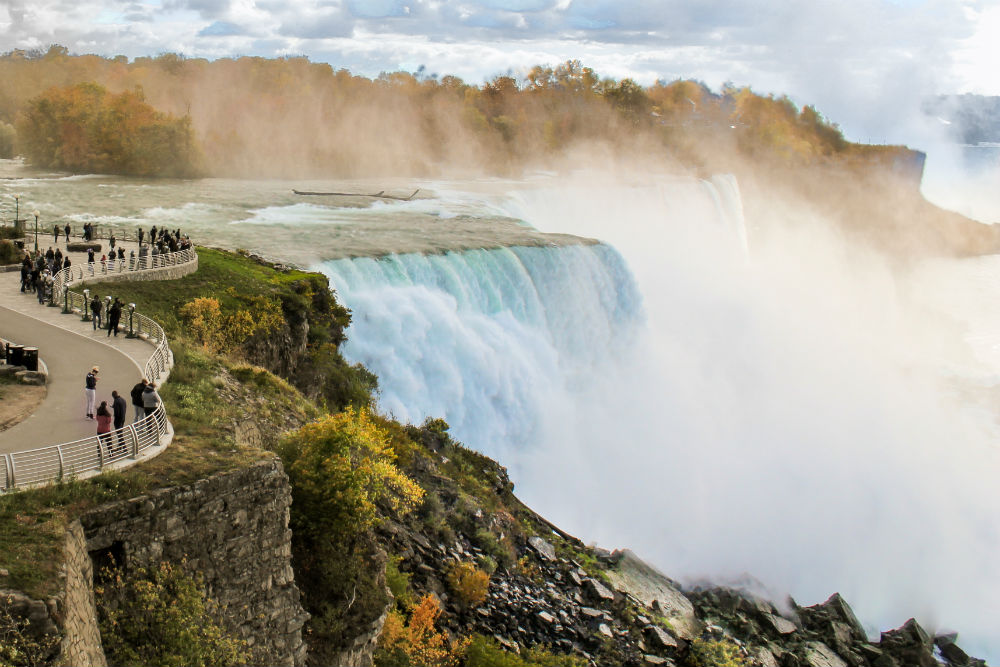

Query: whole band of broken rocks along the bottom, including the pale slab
left=383, top=506, right=985, bottom=667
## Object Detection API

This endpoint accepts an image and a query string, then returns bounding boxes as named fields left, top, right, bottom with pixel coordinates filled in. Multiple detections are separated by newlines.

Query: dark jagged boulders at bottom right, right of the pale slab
left=687, top=588, right=986, bottom=667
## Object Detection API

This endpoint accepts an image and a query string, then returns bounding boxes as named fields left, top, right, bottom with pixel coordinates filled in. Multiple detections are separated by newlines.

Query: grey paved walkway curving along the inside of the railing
left=0, top=235, right=153, bottom=453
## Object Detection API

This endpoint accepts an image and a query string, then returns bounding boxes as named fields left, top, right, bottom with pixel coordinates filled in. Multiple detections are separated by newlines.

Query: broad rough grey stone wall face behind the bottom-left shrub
left=81, top=458, right=308, bottom=665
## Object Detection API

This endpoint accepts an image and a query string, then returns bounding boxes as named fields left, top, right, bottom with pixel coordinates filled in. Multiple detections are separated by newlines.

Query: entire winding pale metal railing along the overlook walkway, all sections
left=0, top=248, right=198, bottom=491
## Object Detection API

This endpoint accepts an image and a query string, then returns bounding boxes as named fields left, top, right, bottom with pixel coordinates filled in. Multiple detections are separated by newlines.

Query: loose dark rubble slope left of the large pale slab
left=378, top=525, right=687, bottom=665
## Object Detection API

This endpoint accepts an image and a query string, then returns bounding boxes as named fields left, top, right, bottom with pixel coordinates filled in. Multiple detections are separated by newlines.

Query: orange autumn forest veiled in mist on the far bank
left=0, top=46, right=919, bottom=178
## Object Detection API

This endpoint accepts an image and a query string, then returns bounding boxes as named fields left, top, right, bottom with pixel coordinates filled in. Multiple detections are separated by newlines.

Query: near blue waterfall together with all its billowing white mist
left=323, top=174, right=1000, bottom=658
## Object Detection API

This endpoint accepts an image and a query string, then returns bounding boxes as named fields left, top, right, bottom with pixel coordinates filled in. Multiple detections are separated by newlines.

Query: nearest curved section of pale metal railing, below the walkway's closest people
left=0, top=403, right=167, bottom=491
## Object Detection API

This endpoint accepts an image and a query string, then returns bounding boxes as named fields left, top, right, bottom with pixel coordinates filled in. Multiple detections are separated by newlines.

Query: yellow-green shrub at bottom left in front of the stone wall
left=94, top=563, right=250, bottom=667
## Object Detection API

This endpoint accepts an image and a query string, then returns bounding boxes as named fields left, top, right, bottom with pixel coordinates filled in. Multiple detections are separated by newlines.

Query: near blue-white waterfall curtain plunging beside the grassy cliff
left=318, top=244, right=642, bottom=462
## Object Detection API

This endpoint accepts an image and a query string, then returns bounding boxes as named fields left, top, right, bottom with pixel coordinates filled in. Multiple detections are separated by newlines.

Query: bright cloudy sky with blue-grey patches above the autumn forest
left=0, top=0, right=1000, bottom=142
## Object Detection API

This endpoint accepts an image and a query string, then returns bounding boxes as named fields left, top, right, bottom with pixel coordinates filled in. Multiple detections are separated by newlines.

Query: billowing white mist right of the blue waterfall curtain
left=505, top=173, right=1000, bottom=660
